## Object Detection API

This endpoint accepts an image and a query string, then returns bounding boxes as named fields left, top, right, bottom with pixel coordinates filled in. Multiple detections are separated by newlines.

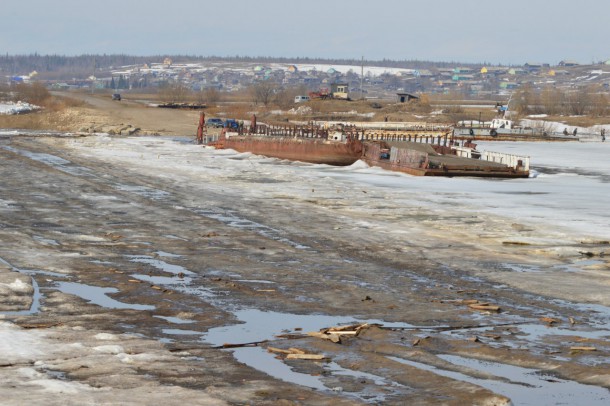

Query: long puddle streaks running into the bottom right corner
left=388, top=355, right=610, bottom=406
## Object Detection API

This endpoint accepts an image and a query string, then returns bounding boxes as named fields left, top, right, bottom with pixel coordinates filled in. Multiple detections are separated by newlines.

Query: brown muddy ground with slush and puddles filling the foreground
left=0, top=96, right=610, bottom=405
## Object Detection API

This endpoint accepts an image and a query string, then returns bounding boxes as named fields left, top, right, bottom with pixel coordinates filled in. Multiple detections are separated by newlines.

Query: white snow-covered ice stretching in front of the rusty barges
left=69, top=136, right=610, bottom=244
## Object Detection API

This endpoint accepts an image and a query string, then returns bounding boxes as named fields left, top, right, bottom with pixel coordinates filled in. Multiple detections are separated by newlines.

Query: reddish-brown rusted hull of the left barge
left=218, top=135, right=362, bottom=166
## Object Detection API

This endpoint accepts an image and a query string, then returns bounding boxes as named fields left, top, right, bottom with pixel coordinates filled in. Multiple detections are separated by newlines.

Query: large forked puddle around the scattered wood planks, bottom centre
left=202, top=309, right=412, bottom=402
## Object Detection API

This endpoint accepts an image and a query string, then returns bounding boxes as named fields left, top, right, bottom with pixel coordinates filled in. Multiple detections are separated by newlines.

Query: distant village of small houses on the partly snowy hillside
left=0, top=58, right=610, bottom=99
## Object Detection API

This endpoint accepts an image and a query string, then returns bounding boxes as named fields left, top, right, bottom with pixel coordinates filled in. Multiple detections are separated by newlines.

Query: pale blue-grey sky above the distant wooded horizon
left=0, top=0, right=610, bottom=65
